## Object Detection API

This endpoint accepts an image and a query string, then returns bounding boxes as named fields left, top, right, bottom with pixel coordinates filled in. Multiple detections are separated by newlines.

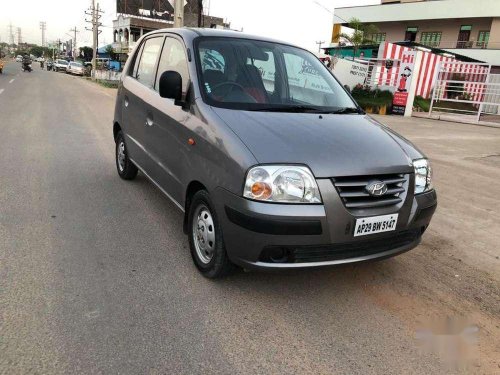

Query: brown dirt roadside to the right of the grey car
left=370, top=117, right=500, bottom=374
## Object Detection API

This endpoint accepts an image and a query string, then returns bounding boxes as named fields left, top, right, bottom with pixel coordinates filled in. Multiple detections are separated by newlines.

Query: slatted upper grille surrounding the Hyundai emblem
left=332, top=174, right=408, bottom=209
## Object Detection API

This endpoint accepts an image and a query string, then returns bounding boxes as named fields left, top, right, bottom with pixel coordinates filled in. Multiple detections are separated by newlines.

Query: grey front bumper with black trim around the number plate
left=215, top=179, right=437, bottom=269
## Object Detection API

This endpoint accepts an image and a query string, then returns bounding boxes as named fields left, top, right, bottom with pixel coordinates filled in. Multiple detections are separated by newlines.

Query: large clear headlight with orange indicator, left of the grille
left=243, top=165, right=321, bottom=203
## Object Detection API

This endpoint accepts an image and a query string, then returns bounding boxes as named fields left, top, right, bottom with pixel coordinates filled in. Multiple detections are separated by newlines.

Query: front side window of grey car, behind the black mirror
left=155, top=37, right=189, bottom=94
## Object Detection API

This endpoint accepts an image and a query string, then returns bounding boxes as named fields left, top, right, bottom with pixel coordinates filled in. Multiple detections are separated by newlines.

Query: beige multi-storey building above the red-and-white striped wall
left=332, top=0, right=500, bottom=66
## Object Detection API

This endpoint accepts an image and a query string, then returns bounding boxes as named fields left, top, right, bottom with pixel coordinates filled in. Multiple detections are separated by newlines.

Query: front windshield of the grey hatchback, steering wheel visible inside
left=196, top=37, right=359, bottom=113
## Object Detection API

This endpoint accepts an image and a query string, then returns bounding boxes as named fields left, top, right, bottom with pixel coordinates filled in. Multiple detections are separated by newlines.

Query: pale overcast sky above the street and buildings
left=0, top=0, right=380, bottom=51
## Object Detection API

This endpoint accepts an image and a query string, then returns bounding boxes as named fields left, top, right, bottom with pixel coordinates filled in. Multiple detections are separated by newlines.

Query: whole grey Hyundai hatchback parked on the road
left=113, top=28, right=437, bottom=278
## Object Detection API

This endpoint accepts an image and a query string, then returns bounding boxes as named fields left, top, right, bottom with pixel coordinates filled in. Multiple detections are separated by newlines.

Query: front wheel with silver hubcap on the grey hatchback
left=188, top=190, right=234, bottom=279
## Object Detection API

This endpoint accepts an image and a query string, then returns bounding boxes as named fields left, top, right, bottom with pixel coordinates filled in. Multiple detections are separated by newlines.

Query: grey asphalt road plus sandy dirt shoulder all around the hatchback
left=0, top=63, right=500, bottom=374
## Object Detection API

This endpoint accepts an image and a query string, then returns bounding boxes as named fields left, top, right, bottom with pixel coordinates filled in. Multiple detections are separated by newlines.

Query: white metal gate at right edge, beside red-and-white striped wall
left=429, top=61, right=500, bottom=123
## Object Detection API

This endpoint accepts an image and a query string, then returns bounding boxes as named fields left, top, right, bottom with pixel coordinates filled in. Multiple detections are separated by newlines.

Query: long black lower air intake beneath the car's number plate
left=260, top=230, right=420, bottom=263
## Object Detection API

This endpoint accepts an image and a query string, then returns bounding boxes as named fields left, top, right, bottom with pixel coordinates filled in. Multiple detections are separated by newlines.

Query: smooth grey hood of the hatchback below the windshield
left=213, top=107, right=422, bottom=178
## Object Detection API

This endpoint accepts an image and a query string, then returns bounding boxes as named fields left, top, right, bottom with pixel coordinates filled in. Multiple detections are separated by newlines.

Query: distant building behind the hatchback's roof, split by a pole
left=112, top=0, right=229, bottom=54
